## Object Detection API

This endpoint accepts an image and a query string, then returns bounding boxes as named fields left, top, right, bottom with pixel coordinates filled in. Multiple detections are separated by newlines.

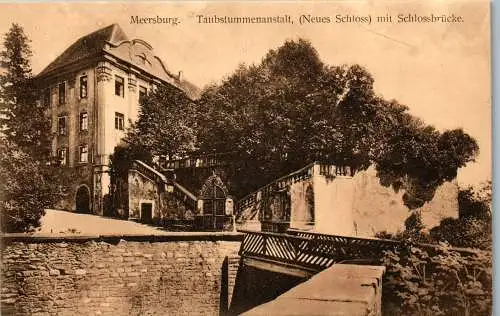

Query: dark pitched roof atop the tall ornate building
left=38, top=23, right=128, bottom=77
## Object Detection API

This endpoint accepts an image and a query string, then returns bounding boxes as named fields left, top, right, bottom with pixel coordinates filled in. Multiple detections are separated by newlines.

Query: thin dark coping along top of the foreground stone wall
left=0, top=232, right=244, bottom=244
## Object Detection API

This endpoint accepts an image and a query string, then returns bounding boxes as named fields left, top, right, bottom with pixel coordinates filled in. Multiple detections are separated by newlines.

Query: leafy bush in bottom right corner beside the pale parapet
left=382, top=246, right=492, bottom=316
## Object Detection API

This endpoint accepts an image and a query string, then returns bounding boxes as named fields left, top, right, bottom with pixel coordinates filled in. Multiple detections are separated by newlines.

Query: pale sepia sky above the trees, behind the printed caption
left=0, top=0, right=492, bottom=185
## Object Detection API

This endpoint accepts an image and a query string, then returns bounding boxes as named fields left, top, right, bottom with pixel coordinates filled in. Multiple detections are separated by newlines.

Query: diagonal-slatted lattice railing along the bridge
left=239, top=231, right=402, bottom=271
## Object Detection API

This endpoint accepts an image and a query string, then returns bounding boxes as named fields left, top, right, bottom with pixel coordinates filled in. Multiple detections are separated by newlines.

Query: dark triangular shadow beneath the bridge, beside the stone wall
left=226, top=259, right=306, bottom=316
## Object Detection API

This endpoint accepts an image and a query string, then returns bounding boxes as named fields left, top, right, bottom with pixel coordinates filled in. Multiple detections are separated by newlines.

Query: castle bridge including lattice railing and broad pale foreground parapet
left=235, top=230, right=475, bottom=316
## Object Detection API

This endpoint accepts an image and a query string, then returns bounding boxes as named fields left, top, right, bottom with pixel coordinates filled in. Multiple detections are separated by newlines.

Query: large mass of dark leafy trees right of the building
left=198, top=40, right=478, bottom=204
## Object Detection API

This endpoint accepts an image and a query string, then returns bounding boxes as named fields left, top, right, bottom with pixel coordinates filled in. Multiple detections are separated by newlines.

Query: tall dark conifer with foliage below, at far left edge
left=0, top=24, right=66, bottom=232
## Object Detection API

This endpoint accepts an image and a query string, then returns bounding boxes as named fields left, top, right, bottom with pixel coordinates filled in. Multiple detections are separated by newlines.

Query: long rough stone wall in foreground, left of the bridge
left=1, top=233, right=241, bottom=315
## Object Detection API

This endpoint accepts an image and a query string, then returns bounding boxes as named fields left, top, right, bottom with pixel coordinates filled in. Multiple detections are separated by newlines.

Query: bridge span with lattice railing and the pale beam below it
left=239, top=230, right=405, bottom=277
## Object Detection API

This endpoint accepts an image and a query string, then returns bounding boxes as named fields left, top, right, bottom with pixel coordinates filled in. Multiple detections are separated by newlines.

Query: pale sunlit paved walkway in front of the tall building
left=35, top=210, right=170, bottom=235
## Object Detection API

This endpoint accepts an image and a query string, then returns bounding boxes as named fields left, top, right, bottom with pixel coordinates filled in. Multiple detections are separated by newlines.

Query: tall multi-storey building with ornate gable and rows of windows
left=36, top=24, right=198, bottom=215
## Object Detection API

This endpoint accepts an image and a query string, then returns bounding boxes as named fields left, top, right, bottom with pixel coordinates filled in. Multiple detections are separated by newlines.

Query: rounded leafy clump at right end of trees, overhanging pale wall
left=374, top=126, right=479, bottom=210
